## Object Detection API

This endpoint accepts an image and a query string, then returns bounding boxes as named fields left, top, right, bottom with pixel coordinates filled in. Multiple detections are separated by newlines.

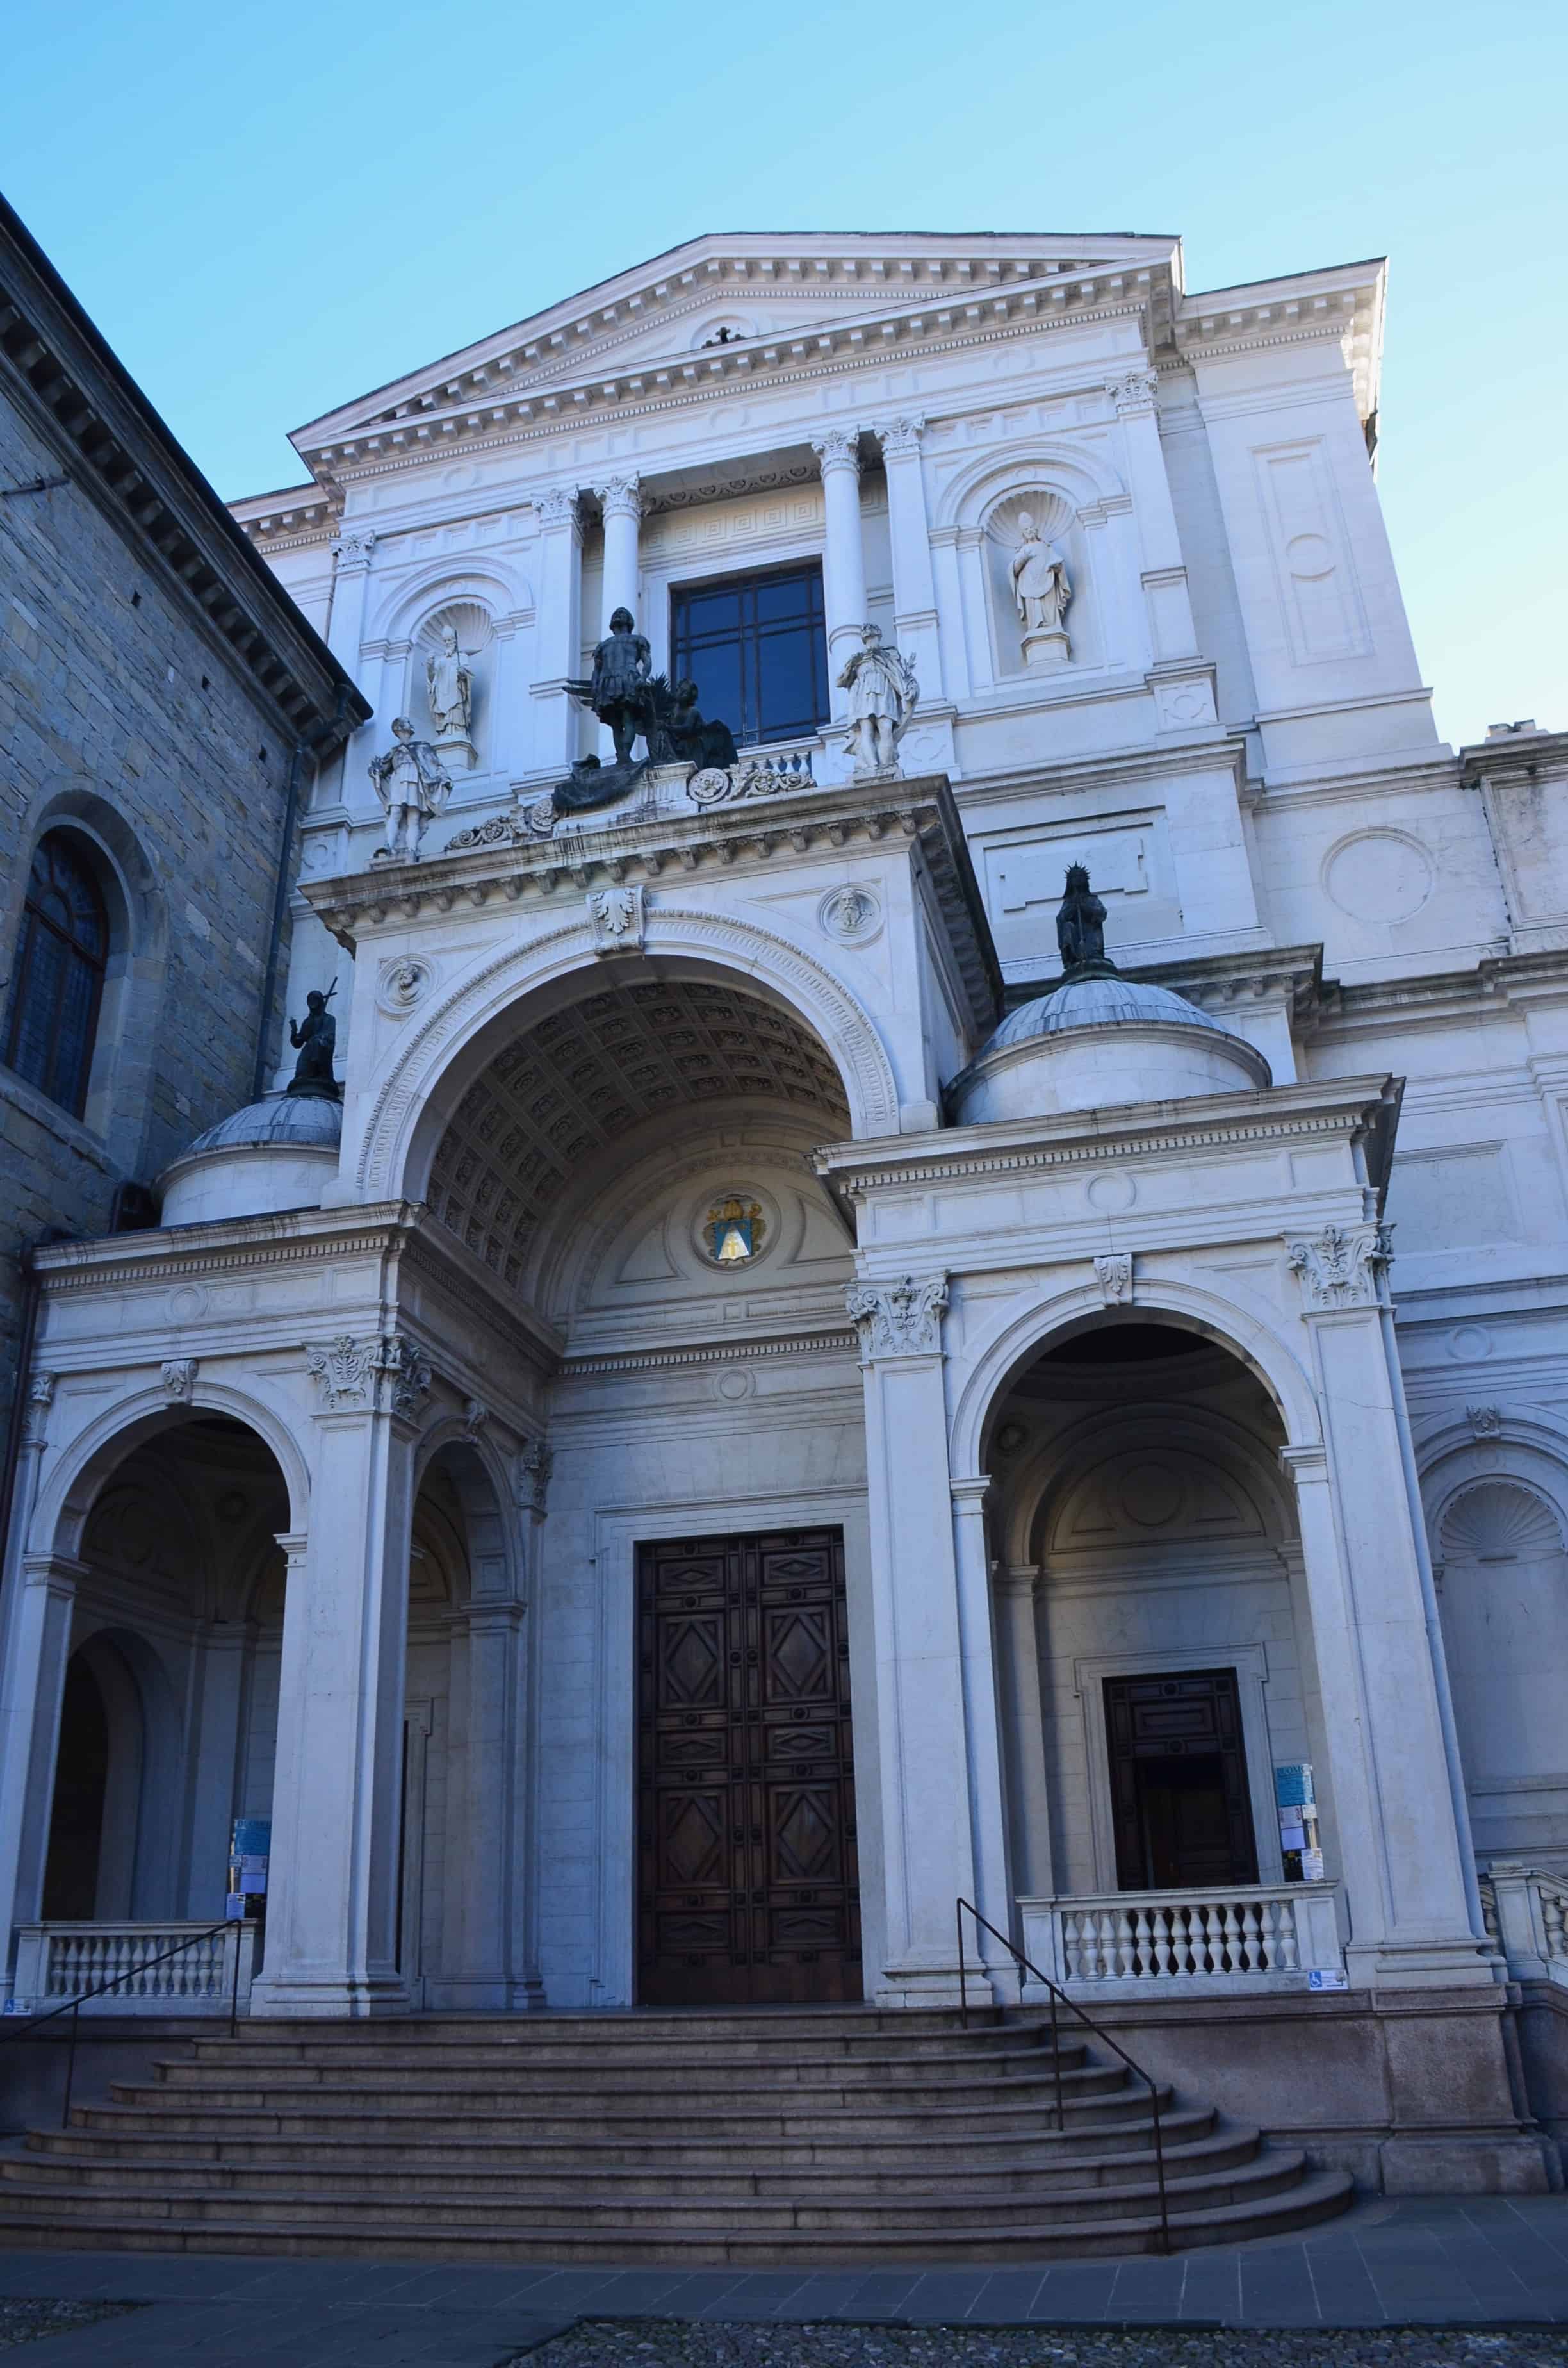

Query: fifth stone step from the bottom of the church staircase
left=71, top=2068, right=1170, bottom=2146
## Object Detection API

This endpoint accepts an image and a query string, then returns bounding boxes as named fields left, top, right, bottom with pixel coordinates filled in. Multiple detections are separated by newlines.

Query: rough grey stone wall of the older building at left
left=0, top=400, right=291, bottom=1433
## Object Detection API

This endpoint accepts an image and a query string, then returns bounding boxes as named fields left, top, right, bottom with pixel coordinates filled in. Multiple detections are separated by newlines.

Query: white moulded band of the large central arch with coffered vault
left=355, top=905, right=897, bottom=1201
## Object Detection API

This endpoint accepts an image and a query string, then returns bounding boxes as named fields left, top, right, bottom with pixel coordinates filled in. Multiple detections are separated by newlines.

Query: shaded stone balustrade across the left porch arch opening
left=12, top=1920, right=258, bottom=2015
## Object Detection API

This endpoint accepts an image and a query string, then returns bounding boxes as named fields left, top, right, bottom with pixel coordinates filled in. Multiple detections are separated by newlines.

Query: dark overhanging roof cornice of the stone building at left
left=0, top=199, right=370, bottom=748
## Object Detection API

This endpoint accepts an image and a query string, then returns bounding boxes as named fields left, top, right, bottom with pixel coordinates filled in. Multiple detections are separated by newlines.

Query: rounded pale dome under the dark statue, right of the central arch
left=947, top=969, right=1272, bottom=1127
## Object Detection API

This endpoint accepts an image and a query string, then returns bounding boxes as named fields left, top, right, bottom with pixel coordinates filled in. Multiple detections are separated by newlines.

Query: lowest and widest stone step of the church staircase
left=0, top=2171, right=1352, bottom=2269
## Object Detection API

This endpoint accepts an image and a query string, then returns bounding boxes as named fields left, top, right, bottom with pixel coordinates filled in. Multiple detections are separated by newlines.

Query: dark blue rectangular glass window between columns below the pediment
left=671, top=561, right=829, bottom=748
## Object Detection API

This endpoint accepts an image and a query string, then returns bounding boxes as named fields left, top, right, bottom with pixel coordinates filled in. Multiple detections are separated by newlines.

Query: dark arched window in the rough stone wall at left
left=0, top=831, right=109, bottom=1118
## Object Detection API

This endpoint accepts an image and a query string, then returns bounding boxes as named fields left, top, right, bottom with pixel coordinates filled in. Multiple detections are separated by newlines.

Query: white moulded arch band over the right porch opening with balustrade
left=947, top=1276, right=1324, bottom=1476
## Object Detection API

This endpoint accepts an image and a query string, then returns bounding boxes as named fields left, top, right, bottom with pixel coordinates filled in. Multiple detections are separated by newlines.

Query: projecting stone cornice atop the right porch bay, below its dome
left=812, top=1075, right=1400, bottom=1201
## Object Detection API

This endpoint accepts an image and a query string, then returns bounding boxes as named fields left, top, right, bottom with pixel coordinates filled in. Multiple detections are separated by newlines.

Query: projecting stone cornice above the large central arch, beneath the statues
left=301, top=775, right=1002, bottom=1030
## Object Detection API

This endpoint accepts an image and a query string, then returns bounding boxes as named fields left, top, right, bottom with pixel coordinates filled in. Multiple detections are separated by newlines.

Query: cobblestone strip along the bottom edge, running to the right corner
left=521, top=2318, right=1568, bottom=2368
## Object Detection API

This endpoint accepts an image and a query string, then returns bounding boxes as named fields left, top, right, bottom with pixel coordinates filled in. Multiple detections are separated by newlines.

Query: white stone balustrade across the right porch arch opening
left=1018, top=1882, right=1343, bottom=1998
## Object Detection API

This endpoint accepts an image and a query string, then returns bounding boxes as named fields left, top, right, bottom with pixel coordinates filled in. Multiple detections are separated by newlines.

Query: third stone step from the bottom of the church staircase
left=15, top=2129, right=1260, bottom=2212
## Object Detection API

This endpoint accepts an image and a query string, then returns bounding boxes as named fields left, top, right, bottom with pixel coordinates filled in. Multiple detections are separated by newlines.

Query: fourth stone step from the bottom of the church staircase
left=26, top=2105, right=1215, bottom=2178
